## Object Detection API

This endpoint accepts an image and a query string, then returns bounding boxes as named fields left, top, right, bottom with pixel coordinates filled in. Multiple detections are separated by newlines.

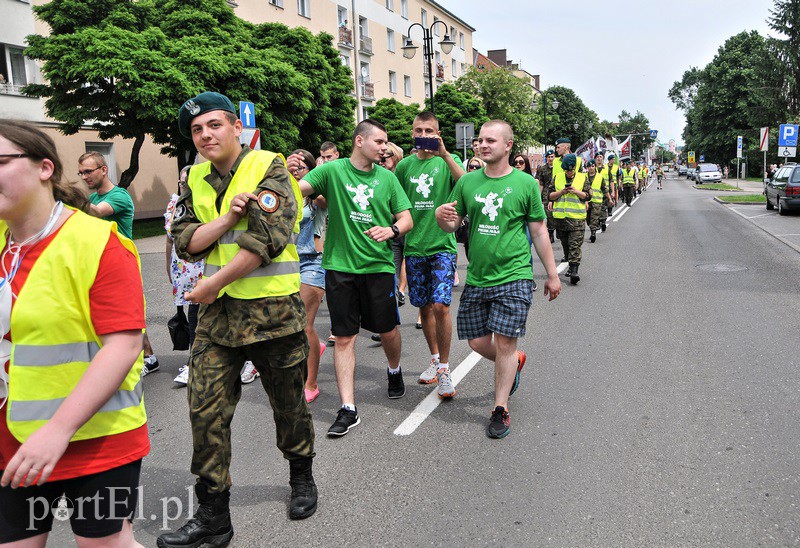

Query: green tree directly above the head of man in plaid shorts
left=455, top=67, right=538, bottom=148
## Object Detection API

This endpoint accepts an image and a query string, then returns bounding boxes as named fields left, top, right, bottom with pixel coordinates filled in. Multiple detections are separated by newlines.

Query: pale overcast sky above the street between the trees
left=437, top=0, right=773, bottom=144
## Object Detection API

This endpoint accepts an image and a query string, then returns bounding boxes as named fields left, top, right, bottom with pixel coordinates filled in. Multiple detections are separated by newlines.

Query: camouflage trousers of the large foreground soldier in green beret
left=188, top=331, right=314, bottom=493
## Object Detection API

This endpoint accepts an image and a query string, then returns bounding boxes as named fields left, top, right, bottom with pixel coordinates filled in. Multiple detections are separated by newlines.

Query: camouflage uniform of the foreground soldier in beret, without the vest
left=172, top=147, right=315, bottom=493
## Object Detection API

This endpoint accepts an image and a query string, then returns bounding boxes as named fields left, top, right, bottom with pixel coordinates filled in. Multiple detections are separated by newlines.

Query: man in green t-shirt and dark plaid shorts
left=436, top=120, right=561, bottom=438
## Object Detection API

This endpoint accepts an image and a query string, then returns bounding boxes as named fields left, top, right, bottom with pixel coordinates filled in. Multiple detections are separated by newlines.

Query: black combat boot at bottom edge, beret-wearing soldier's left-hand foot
left=156, top=483, right=233, bottom=548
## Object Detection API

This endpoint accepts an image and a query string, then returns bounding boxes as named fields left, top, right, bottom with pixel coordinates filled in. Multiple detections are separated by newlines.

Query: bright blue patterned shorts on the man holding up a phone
left=406, top=253, right=456, bottom=308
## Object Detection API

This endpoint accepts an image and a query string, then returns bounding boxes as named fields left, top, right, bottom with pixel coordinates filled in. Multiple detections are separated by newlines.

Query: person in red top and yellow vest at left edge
left=0, top=120, right=150, bottom=546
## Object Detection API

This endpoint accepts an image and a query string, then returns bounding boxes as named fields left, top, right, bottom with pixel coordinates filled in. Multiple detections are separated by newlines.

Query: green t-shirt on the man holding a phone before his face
left=394, top=154, right=460, bottom=257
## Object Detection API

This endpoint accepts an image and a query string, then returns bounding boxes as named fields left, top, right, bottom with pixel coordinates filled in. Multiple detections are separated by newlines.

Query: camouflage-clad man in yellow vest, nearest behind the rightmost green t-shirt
left=547, top=154, right=592, bottom=285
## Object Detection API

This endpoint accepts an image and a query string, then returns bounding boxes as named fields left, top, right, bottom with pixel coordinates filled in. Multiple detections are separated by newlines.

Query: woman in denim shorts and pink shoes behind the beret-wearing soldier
left=292, top=149, right=328, bottom=403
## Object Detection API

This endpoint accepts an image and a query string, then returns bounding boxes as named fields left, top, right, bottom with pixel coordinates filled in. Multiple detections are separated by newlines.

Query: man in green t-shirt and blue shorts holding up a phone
left=395, top=111, right=464, bottom=398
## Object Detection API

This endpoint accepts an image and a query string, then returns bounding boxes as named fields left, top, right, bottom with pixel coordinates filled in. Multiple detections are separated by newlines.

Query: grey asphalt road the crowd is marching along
left=48, top=174, right=800, bottom=547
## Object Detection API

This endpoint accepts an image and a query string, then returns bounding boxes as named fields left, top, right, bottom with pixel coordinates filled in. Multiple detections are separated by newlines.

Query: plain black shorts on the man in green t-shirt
left=325, top=270, right=400, bottom=337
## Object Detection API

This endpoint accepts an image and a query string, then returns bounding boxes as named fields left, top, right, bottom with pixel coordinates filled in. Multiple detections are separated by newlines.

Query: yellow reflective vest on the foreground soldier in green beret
left=188, top=151, right=303, bottom=299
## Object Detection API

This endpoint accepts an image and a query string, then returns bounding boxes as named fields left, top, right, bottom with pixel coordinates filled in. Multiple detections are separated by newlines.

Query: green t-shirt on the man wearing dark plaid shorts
left=448, top=169, right=545, bottom=287
